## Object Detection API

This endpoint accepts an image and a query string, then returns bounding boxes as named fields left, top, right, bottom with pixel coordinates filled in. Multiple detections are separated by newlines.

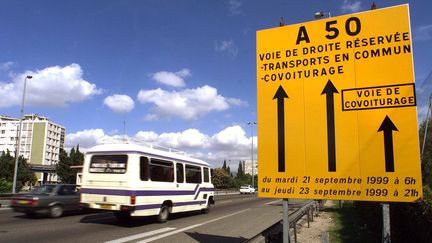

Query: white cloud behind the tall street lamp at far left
left=0, top=63, right=102, bottom=107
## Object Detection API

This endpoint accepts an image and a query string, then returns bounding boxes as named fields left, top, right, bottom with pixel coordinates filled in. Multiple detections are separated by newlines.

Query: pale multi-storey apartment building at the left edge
left=0, top=114, right=66, bottom=182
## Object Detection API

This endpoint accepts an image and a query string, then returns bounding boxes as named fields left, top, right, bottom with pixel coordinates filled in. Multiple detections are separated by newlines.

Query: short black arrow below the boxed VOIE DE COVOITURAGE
left=378, top=116, right=399, bottom=172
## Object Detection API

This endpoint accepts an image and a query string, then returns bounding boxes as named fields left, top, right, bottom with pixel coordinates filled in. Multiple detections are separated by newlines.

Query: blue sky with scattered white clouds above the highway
left=0, top=0, right=432, bottom=167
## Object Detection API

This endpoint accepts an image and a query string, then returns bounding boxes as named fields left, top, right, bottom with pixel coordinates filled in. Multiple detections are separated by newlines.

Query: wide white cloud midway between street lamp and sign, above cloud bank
left=138, top=85, right=241, bottom=121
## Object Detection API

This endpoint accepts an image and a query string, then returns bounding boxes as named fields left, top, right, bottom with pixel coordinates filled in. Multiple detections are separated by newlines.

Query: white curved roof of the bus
left=86, top=143, right=210, bottom=166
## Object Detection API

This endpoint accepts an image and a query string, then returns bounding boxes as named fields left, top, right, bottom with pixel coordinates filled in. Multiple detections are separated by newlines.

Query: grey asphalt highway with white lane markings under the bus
left=0, top=195, right=310, bottom=243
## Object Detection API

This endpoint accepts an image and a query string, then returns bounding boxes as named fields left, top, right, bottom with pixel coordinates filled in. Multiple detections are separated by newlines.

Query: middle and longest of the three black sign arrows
left=321, top=80, right=339, bottom=172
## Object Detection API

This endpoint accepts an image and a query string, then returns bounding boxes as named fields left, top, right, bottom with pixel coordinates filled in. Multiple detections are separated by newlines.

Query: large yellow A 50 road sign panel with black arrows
left=256, top=5, right=422, bottom=202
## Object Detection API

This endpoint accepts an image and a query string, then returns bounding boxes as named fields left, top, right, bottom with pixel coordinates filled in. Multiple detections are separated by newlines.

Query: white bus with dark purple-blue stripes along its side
left=81, top=144, right=214, bottom=223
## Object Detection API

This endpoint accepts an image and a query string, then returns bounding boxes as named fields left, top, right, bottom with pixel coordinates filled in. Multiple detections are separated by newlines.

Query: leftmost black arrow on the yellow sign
left=273, top=85, right=289, bottom=172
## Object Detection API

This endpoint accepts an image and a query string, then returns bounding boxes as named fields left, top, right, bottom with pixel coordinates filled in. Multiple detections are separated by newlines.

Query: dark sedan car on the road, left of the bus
left=11, top=184, right=80, bottom=218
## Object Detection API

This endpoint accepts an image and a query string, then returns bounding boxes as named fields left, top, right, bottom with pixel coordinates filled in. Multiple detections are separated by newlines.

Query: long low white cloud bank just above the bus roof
left=66, top=125, right=257, bottom=167
